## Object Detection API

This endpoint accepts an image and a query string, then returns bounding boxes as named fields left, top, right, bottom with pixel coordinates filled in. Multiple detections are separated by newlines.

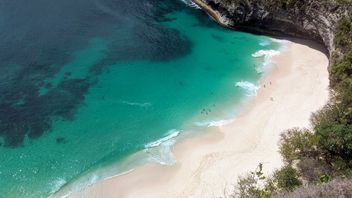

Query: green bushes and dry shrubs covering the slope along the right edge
left=236, top=7, right=352, bottom=198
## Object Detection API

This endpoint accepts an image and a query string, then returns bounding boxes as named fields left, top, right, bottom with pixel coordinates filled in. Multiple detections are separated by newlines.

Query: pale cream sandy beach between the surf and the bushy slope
left=65, top=40, right=329, bottom=198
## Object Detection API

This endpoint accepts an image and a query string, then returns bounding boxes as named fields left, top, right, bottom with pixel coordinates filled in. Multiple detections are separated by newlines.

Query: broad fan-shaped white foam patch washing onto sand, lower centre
left=144, top=129, right=181, bottom=166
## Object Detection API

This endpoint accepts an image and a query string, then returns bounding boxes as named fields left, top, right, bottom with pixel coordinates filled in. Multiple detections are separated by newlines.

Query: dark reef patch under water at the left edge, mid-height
left=0, top=66, right=91, bottom=147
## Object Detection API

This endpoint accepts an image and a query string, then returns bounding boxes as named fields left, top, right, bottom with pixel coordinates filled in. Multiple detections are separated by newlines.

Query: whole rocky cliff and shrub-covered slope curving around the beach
left=193, top=0, right=352, bottom=197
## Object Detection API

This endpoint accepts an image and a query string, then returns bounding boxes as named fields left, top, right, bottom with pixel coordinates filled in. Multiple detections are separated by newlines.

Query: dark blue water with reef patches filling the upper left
left=0, top=0, right=198, bottom=148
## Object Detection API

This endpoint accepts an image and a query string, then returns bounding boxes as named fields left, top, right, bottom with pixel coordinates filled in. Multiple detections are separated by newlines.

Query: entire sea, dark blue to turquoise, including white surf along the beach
left=0, top=0, right=280, bottom=198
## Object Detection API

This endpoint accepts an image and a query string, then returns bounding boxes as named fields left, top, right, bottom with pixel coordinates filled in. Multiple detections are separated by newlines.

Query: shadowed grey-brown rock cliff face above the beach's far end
left=195, top=0, right=352, bottom=54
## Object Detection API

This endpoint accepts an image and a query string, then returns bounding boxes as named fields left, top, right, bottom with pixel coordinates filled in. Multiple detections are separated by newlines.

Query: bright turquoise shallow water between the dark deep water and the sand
left=0, top=1, right=278, bottom=197
